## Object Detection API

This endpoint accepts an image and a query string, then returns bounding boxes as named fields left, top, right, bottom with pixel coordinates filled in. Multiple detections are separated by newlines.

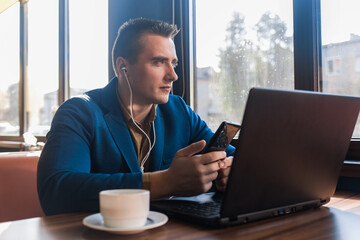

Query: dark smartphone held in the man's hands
left=202, top=121, right=241, bottom=153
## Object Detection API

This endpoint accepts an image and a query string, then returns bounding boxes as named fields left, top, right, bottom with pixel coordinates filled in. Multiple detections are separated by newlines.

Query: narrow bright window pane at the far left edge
left=0, top=3, right=20, bottom=135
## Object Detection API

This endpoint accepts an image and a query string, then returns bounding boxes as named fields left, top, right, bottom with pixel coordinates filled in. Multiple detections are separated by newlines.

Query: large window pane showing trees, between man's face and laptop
left=195, top=0, right=294, bottom=131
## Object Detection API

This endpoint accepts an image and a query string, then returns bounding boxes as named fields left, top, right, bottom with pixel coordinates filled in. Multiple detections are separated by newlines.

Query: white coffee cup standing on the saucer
left=99, top=189, right=150, bottom=229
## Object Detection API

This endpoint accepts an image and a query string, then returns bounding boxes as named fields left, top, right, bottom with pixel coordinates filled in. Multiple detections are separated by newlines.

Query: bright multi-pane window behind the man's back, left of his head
left=0, top=0, right=108, bottom=141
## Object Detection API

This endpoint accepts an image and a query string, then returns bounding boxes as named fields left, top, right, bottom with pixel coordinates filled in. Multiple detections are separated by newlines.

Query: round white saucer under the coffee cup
left=83, top=211, right=168, bottom=235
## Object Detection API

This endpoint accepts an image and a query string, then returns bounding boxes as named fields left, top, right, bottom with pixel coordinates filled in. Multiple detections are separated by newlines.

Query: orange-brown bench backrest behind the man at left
left=0, top=152, right=44, bottom=222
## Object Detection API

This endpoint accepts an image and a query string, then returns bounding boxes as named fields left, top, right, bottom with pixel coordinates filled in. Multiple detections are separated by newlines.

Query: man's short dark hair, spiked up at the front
left=112, top=18, right=179, bottom=74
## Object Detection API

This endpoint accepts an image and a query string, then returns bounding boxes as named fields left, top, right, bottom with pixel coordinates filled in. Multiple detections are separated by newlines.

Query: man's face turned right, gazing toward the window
left=127, top=34, right=178, bottom=106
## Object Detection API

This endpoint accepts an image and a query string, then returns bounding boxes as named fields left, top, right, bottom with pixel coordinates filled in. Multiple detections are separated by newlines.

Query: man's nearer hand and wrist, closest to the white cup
left=150, top=140, right=226, bottom=199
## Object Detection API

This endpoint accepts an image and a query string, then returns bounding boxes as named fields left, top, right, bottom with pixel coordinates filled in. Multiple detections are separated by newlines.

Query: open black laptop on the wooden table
left=151, top=88, right=360, bottom=227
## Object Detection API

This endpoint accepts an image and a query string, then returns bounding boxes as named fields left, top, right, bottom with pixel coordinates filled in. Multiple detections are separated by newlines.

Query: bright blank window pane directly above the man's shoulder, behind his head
left=69, top=0, right=108, bottom=97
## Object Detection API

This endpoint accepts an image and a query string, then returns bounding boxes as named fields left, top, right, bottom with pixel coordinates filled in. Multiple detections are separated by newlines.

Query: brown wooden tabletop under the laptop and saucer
left=0, top=192, right=360, bottom=240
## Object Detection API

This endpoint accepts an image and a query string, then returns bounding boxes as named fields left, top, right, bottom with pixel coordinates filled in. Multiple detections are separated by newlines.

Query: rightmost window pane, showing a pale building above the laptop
left=321, top=0, right=360, bottom=138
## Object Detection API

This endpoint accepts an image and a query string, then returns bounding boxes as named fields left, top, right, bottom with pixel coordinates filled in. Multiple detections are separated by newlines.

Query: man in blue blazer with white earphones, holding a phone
left=38, top=19, right=234, bottom=215
